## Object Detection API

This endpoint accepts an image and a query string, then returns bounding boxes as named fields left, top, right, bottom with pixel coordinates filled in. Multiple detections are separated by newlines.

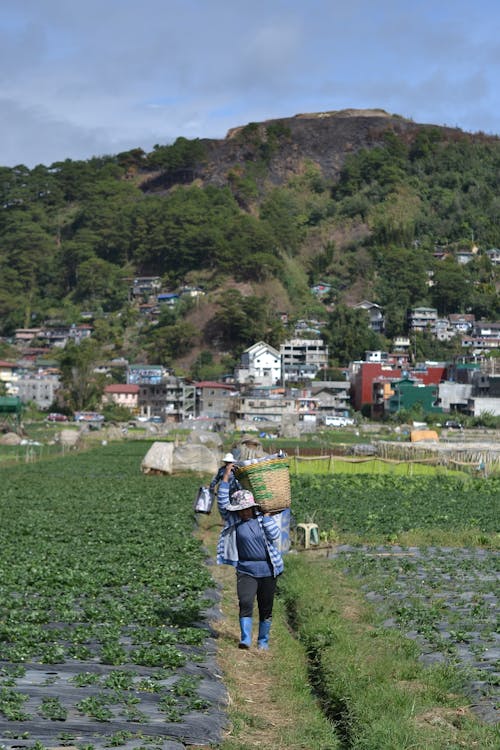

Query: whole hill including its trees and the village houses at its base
left=0, top=110, right=500, bottom=431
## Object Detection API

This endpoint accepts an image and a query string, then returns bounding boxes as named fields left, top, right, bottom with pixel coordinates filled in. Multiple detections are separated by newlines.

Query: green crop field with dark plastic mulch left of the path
left=0, top=442, right=225, bottom=749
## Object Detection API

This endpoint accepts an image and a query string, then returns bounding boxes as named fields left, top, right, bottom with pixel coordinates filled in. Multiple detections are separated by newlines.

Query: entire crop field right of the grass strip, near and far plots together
left=292, top=475, right=500, bottom=723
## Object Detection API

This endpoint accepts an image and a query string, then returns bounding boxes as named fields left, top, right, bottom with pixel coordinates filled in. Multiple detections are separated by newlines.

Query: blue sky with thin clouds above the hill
left=0, top=0, right=500, bottom=169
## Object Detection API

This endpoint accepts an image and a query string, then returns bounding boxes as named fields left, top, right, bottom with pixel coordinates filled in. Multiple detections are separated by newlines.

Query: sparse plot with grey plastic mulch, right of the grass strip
left=332, top=545, right=500, bottom=723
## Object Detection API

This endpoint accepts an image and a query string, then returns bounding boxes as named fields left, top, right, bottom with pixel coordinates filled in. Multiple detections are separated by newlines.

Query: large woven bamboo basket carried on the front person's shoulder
left=234, top=458, right=291, bottom=513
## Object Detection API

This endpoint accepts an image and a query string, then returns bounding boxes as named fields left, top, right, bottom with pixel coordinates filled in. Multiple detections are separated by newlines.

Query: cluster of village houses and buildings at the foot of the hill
left=0, top=274, right=500, bottom=431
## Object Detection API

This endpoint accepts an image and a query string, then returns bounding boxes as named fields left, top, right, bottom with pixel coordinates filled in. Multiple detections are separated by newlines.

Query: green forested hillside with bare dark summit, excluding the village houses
left=0, top=110, right=500, bottom=374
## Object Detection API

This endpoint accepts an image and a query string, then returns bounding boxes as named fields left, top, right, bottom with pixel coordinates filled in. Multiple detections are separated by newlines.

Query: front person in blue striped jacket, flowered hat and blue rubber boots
left=217, top=463, right=283, bottom=649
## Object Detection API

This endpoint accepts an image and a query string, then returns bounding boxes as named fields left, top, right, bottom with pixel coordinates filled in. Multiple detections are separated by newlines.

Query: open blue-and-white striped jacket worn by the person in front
left=217, top=482, right=284, bottom=578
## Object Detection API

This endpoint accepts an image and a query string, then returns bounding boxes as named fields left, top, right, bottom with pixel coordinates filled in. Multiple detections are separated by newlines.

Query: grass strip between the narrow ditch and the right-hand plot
left=281, top=555, right=499, bottom=750
